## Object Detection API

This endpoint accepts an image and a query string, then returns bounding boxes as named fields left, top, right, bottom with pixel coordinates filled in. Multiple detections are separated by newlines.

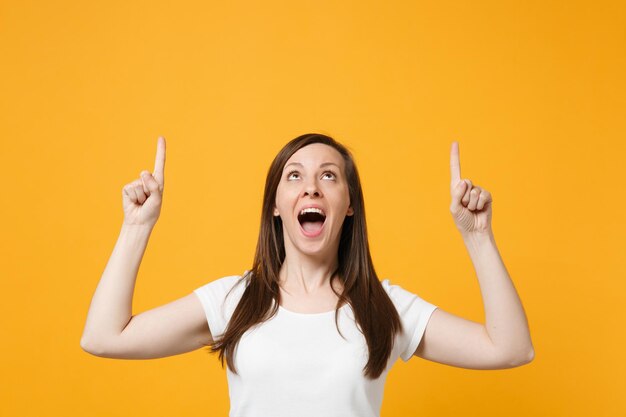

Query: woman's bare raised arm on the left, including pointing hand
left=80, top=138, right=212, bottom=359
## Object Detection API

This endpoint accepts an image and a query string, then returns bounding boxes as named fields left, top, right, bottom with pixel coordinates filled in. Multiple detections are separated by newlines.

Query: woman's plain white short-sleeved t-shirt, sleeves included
left=193, top=275, right=437, bottom=417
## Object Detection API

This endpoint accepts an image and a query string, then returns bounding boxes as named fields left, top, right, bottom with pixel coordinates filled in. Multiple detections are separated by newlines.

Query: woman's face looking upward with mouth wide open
left=274, top=143, right=354, bottom=255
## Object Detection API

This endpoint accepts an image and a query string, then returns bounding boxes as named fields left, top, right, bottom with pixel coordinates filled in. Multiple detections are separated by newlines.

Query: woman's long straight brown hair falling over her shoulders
left=209, top=133, right=403, bottom=379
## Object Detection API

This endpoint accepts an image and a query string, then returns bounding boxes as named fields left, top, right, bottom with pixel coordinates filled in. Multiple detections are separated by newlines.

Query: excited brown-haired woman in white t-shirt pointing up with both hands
left=81, top=133, right=534, bottom=417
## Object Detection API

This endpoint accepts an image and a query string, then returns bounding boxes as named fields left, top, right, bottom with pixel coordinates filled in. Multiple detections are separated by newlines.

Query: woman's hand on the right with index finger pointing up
left=450, top=142, right=492, bottom=234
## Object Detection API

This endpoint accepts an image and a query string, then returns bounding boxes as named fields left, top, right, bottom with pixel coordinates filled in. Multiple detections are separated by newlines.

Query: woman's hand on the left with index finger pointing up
left=122, top=136, right=165, bottom=227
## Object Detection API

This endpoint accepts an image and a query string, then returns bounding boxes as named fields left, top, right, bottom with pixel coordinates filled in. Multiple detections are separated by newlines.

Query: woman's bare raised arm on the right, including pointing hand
left=414, top=142, right=535, bottom=369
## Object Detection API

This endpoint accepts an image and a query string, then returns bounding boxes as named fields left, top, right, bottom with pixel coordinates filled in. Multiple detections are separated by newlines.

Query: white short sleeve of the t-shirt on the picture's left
left=193, top=271, right=247, bottom=339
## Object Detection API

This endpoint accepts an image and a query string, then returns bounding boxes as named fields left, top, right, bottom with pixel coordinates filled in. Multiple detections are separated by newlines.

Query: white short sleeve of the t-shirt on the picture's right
left=381, top=279, right=437, bottom=362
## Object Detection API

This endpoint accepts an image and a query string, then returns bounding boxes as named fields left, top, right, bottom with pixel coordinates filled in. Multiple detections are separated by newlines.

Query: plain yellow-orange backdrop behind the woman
left=0, top=0, right=626, bottom=417
